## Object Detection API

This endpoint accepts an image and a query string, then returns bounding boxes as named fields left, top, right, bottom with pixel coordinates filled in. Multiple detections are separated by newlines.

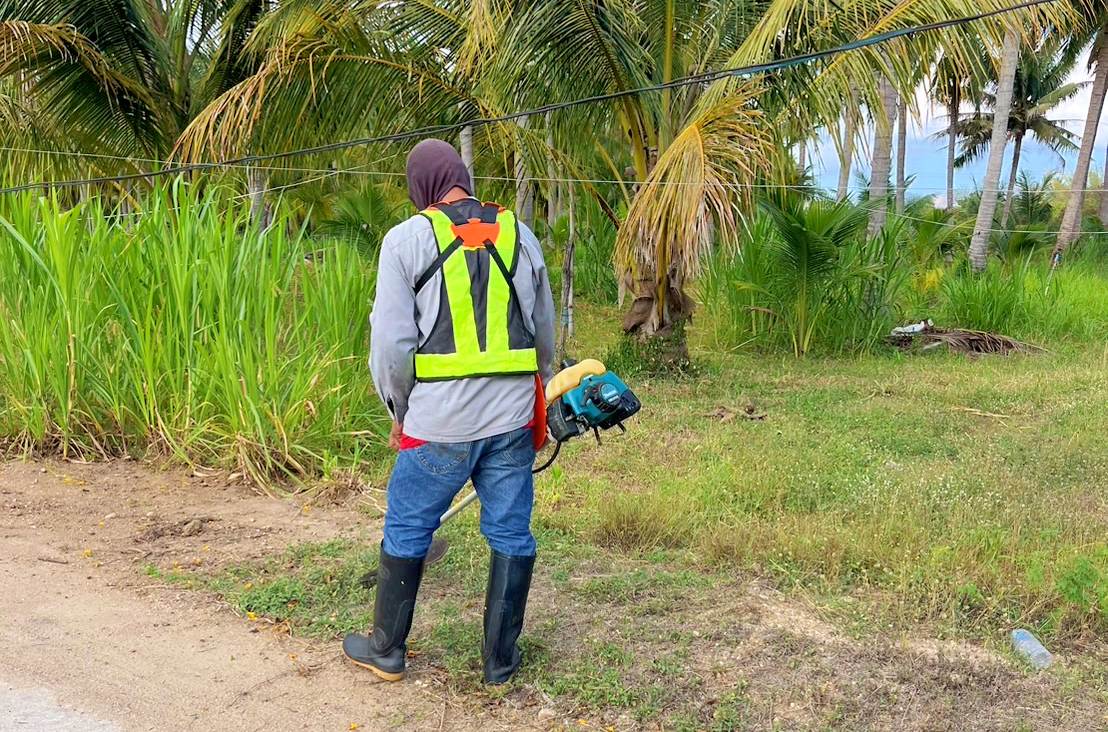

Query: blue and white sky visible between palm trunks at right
left=809, top=63, right=1108, bottom=205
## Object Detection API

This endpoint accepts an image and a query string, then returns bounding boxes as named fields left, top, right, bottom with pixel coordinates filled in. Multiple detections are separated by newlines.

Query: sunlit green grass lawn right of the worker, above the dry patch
left=567, top=307, right=1108, bottom=638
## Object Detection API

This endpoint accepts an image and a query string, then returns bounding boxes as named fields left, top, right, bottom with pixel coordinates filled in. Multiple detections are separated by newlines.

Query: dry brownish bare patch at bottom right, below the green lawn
left=538, top=555, right=1108, bottom=732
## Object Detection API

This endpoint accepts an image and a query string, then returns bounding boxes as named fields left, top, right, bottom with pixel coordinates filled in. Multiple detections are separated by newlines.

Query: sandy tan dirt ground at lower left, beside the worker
left=0, top=462, right=526, bottom=732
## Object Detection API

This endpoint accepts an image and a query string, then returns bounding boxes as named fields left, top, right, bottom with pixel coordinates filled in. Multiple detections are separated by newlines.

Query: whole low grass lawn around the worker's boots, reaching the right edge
left=158, top=308, right=1108, bottom=730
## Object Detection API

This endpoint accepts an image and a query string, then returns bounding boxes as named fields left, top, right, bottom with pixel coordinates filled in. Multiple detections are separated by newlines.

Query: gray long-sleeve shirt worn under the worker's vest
left=369, top=202, right=554, bottom=442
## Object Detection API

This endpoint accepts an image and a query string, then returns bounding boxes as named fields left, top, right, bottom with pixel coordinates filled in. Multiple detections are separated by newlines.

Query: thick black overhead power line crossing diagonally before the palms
left=0, top=0, right=1059, bottom=194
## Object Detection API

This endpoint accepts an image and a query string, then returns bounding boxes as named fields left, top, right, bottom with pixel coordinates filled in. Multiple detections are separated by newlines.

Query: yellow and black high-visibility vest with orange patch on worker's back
left=416, top=204, right=538, bottom=381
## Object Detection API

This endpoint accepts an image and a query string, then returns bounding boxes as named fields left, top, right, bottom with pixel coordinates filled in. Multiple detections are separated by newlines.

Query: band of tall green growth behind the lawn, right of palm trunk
left=699, top=192, right=1108, bottom=355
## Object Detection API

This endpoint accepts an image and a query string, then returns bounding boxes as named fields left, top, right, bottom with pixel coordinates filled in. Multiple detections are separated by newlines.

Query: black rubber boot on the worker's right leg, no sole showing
left=481, top=551, right=535, bottom=683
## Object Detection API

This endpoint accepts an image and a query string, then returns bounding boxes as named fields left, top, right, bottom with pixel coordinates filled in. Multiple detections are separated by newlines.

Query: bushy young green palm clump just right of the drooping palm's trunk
left=700, top=197, right=910, bottom=357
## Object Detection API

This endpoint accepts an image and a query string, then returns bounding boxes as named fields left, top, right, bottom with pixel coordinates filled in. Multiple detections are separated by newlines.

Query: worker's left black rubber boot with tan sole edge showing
left=342, top=548, right=423, bottom=681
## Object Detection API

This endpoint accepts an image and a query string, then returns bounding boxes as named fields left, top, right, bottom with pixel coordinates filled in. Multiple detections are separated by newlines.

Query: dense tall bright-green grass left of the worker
left=0, top=182, right=383, bottom=482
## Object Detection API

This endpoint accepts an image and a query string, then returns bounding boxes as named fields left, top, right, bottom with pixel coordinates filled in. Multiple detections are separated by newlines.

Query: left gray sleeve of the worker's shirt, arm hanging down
left=369, top=233, right=419, bottom=424
